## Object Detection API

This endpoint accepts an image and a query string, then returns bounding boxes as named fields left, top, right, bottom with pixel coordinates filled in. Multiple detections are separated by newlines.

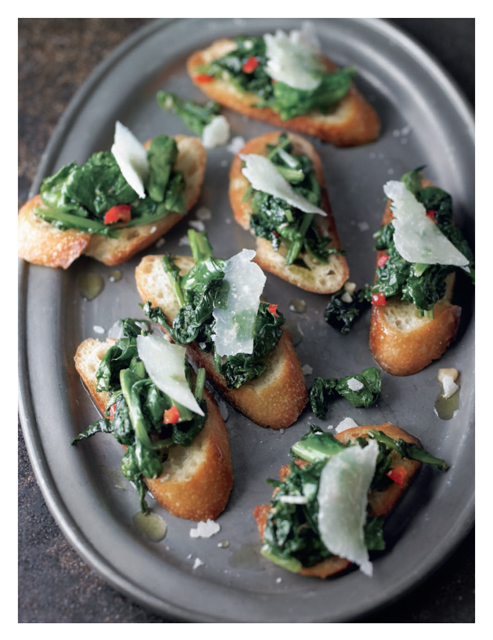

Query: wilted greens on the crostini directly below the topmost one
left=245, top=133, right=343, bottom=267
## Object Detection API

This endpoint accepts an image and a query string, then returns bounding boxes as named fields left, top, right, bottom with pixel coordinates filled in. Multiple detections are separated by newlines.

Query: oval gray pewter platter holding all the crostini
left=19, top=19, right=474, bottom=622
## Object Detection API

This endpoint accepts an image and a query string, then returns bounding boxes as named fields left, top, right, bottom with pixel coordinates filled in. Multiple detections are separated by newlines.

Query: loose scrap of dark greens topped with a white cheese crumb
left=310, top=367, right=382, bottom=420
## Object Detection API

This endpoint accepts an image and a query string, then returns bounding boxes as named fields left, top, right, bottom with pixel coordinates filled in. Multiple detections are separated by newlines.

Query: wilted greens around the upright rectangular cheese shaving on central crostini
left=143, top=230, right=284, bottom=389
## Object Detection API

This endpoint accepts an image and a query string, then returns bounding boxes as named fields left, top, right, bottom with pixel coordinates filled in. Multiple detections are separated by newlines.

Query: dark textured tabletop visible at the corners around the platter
left=18, top=18, right=475, bottom=623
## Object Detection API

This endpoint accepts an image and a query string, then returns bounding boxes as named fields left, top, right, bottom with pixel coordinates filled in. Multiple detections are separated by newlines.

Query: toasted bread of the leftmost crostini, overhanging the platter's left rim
left=18, top=136, right=206, bottom=269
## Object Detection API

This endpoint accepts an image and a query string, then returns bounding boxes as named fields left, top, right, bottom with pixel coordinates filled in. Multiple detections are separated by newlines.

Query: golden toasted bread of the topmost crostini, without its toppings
left=187, top=39, right=380, bottom=147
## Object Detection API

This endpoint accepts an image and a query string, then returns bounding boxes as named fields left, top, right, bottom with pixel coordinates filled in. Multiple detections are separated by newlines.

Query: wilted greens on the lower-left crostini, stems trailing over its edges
left=72, top=318, right=207, bottom=512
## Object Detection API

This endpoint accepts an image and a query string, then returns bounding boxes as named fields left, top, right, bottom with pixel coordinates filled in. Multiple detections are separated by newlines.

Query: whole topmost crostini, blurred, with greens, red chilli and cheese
left=187, top=23, right=380, bottom=147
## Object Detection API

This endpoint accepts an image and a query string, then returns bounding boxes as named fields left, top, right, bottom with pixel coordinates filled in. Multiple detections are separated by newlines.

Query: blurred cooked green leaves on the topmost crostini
left=195, top=36, right=356, bottom=120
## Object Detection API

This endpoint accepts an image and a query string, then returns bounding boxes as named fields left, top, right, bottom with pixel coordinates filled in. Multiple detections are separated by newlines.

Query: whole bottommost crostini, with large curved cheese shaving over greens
left=253, top=423, right=447, bottom=578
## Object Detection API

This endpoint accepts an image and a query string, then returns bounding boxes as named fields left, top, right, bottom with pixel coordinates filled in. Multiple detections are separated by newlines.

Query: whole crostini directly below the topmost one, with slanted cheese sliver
left=229, top=132, right=349, bottom=294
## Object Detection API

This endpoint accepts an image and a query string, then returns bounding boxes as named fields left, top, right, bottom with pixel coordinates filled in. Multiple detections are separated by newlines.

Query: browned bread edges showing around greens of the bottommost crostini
left=253, top=422, right=421, bottom=578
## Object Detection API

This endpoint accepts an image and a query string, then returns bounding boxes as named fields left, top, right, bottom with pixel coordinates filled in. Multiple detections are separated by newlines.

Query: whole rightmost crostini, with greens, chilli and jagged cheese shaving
left=368, top=167, right=474, bottom=376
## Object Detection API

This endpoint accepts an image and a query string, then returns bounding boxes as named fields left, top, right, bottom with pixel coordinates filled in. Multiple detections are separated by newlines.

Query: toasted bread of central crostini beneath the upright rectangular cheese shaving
left=135, top=256, right=308, bottom=429
